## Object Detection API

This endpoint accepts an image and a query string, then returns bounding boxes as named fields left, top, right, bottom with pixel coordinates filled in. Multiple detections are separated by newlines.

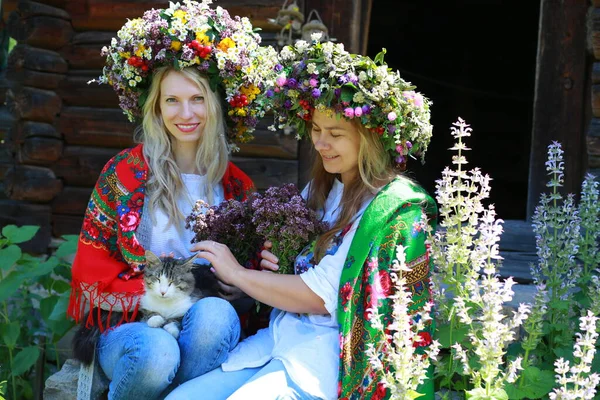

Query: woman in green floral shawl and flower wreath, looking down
left=173, top=37, right=437, bottom=399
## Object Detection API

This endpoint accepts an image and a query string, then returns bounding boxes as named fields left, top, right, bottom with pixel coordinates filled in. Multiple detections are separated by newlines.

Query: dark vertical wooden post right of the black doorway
left=527, top=0, right=588, bottom=219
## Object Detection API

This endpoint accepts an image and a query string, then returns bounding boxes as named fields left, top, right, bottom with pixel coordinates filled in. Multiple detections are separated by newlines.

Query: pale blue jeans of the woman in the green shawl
left=165, top=360, right=318, bottom=400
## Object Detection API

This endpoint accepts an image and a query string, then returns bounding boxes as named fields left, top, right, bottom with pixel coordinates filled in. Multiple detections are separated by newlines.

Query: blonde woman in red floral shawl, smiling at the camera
left=68, top=0, right=275, bottom=400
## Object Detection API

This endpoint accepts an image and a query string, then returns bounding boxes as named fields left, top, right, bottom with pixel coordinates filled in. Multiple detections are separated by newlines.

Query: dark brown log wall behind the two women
left=0, top=0, right=304, bottom=252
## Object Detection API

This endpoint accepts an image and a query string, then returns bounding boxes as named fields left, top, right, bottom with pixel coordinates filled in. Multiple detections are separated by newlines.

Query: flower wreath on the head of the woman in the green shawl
left=269, top=33, right=432, bottom=168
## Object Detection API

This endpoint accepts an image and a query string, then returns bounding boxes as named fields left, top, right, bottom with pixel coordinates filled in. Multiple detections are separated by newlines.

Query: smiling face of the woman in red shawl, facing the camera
left=159, top=70, right=206, bottom=148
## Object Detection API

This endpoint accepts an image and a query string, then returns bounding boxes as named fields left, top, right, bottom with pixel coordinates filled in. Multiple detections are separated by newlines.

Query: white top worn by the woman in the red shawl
left=136, top=174, right=225, bottom=261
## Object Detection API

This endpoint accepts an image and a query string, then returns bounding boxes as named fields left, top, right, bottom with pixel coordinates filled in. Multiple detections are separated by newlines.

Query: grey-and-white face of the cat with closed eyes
left=144, top=251, right=195, bottom=299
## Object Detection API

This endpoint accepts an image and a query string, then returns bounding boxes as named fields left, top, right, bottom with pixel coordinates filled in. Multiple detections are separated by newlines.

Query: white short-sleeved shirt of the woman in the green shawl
left=222, top=180, right=372, bottom=399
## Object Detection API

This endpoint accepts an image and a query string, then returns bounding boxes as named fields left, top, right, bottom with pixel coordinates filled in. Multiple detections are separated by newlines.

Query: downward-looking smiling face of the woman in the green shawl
left=311, top=110, right=360, bottom=183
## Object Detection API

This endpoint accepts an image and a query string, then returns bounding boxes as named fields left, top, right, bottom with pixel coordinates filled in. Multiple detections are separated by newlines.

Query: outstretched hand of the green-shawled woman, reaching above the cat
left=191, top=240, right=244, bottom=286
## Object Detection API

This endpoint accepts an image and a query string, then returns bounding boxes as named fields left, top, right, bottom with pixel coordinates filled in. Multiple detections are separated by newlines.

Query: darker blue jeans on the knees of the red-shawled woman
left=97, top=297, right=240, bottom=400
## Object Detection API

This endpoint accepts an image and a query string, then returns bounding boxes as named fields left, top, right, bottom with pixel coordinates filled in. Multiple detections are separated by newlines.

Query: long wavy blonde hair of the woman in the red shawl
left=136, top=67, right=229, bottom=227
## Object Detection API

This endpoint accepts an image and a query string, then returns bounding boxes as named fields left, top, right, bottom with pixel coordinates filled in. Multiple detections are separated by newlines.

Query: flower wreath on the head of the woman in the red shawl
left=98, top=0, right=277, bottom=149
